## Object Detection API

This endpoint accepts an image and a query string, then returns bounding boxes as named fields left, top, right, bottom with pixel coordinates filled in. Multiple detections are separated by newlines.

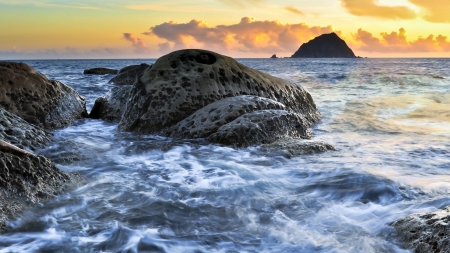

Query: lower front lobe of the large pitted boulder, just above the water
left=208, top=110, right=312, bottom=147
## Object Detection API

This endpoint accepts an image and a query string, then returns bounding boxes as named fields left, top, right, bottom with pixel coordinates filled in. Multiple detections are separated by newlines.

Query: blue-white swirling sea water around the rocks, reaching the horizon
left=0, top=59, right=450, bottom=253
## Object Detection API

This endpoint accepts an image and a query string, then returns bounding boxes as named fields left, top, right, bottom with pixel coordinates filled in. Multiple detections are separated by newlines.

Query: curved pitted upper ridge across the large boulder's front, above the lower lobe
left=164, top=95, right=286, bottom=138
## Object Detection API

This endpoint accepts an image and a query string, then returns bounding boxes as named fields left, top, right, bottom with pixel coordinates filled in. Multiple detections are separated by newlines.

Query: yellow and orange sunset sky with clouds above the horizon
left=0, top=0, right=450, bottom=60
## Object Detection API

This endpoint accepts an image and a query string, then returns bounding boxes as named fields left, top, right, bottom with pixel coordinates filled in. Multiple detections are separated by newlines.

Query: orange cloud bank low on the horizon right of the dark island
left=354, top=28, right=450, bottom=53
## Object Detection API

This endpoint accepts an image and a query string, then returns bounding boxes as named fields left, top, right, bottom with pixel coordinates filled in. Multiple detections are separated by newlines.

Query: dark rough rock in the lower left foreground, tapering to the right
left=0, top=151, right=83, bottom=232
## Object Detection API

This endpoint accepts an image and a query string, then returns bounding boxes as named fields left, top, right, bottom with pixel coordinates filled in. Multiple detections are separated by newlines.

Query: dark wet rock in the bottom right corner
left=391, top=206, right=450, bottom=253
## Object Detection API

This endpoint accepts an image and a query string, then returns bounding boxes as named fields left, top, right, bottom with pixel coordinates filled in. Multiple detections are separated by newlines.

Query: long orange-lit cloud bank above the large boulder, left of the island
left=145, top=17, right=339, bottom=54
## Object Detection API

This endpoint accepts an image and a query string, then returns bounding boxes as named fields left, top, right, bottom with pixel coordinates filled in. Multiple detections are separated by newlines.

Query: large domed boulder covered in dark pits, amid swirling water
left=113, top=49, right=321, bottom=147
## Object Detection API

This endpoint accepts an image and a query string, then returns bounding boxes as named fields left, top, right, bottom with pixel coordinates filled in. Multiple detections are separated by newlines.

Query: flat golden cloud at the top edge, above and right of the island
left=341, top=0, right=418, bottom=19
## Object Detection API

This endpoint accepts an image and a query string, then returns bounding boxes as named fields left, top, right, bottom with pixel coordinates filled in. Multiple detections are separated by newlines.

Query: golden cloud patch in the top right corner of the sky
left=409, top=0, right=450, bottom=23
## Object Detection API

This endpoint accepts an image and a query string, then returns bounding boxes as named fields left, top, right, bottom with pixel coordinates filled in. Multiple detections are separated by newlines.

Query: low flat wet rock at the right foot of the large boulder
left=260, top=138, right=336, bottom=158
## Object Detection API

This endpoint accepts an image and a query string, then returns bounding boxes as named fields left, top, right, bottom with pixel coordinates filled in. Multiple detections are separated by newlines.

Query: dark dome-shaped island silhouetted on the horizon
left=292, top=32, right=356, bottom=58
